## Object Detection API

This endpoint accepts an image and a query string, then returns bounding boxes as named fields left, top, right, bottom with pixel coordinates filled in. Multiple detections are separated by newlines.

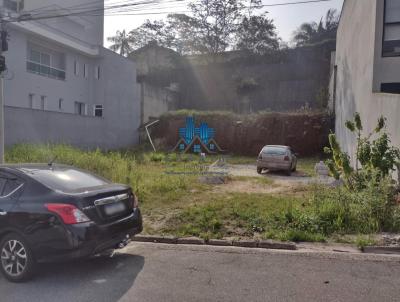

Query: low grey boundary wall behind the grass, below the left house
left=4, top=106, right=138, bottom=149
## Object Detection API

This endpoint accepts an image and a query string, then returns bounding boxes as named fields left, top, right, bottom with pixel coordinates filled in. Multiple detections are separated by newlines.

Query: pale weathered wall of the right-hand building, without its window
left=335, top=0, right=400, bottom=164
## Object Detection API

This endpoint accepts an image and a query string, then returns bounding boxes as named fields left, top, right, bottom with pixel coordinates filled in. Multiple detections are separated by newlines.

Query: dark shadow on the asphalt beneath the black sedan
left=0, top=254, right=144, bottom=302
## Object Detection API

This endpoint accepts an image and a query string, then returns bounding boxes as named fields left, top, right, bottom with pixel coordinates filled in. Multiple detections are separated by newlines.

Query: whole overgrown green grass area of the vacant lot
left=6, top=144, right=400, bottom=241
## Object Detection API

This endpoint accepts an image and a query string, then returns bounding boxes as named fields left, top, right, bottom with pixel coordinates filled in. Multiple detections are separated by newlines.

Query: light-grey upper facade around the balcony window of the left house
left=4, top=29, right=95, bottom=113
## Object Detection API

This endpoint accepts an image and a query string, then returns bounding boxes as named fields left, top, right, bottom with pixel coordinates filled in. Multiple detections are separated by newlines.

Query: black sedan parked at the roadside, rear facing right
left=0, top=164, right=142, bottom=282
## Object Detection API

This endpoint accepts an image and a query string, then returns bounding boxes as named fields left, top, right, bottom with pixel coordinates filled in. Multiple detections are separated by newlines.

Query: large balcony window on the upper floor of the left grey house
left=26, top=44, right=65, bottom=80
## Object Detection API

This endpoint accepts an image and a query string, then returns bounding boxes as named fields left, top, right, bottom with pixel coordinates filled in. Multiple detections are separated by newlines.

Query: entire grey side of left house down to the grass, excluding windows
left=4, top=13, right=140, bottom=149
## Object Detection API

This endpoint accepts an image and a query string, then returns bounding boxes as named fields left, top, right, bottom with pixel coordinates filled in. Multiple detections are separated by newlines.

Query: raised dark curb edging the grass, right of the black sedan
left=132, top=235, right=297, bottom=251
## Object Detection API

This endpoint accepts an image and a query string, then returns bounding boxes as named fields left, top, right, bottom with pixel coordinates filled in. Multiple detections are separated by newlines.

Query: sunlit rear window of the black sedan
left=21, top=168, right=109, bottom=193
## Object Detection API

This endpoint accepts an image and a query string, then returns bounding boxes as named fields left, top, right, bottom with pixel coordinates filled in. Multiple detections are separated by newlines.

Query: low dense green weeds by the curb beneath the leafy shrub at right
left=259, top=177, right=400, bottom=241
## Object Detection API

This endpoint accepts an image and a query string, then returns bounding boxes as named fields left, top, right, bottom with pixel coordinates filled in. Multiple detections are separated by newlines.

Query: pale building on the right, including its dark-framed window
left=331, top=0, right=400, bottom=163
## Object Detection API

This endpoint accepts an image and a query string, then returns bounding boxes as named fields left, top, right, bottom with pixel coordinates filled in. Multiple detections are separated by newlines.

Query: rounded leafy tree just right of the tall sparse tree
left=236, top=14, right=279, bottom=54
